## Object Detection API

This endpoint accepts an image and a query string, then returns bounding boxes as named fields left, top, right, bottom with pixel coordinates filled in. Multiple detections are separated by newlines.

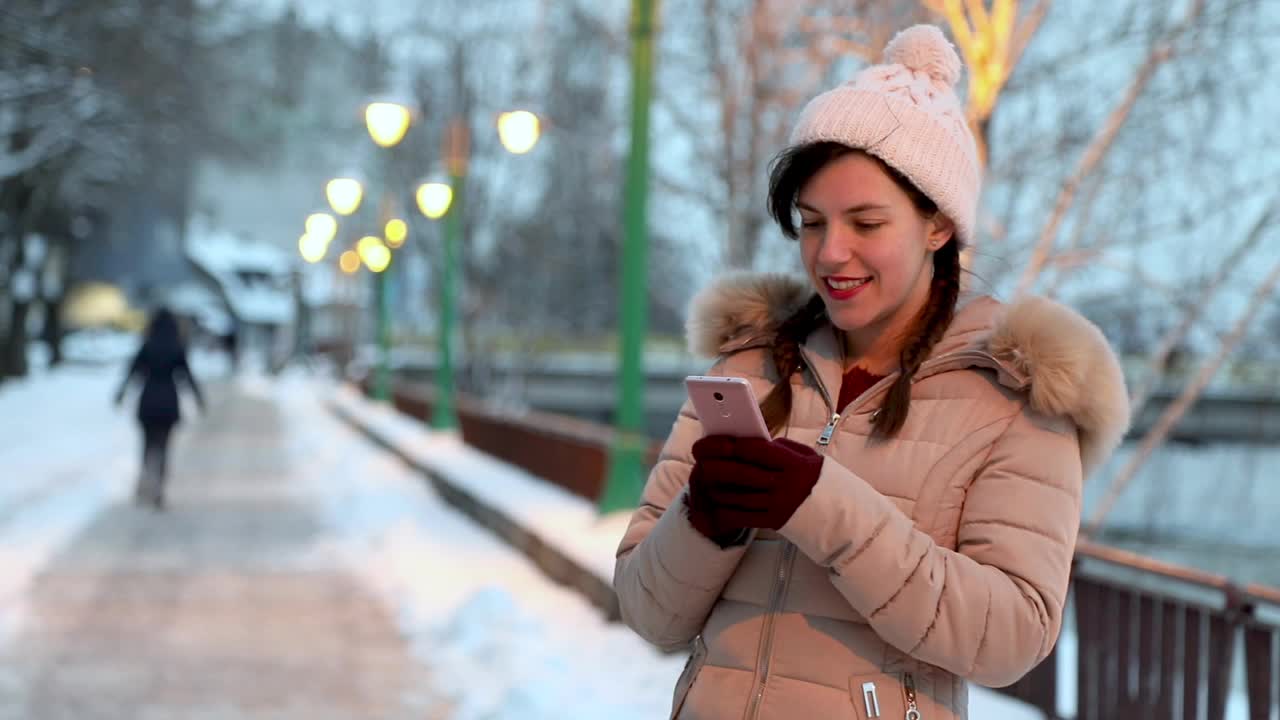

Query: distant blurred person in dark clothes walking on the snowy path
left=115, top=307, right=205, bottom=510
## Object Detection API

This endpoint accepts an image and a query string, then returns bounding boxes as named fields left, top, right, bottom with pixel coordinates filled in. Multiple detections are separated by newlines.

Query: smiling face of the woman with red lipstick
left=796, top=152, right=952, bottom=354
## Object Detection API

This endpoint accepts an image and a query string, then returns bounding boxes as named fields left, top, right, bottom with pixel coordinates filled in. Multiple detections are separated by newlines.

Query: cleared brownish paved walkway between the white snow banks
left=0, top=376, right=443, bottom=720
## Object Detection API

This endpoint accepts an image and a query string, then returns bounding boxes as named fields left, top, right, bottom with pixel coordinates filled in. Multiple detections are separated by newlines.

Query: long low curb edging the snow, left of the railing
left=325, top=389, right=622, bottom=623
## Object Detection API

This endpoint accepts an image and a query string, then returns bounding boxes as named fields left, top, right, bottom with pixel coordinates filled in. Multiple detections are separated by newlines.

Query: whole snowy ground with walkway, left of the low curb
left=0, top=368, right=685, bottom=720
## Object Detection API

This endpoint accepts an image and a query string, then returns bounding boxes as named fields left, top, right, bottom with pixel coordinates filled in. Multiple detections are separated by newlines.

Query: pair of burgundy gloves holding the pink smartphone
left=689, top=436, right=823, bottom=539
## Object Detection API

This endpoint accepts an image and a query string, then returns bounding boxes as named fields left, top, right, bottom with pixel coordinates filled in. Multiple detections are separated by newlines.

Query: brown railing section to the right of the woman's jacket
left=1002, top=541, right=1280, bottom=720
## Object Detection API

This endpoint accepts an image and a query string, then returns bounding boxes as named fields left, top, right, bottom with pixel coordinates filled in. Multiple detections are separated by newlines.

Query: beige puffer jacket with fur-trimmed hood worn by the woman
left=613, top=275, right=1129, bottom=720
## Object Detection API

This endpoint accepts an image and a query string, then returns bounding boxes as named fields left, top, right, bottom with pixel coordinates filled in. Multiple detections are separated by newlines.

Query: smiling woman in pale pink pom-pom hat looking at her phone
left=614, top=26, right=1129, bottom=720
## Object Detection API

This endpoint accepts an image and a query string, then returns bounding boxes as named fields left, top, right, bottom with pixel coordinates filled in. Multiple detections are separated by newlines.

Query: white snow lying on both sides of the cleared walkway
left=0, top=365, right=1244, bottom=720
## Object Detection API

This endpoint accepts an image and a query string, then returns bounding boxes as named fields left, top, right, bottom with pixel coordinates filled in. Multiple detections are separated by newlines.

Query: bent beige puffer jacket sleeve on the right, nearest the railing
left=781, top=410, right=1083, bottom=687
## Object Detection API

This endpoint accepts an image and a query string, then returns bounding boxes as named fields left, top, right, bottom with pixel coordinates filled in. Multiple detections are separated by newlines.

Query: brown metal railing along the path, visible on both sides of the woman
left=373, top=384, right=1280, bottom=720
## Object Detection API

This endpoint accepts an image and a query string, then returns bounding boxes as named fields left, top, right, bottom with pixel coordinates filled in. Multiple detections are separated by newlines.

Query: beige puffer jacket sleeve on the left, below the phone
left=613, top=363, right=746, bottom=650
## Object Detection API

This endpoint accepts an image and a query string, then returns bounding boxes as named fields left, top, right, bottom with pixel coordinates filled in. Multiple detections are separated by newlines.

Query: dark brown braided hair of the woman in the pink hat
left=760, top=137, right=961, bottom=437
